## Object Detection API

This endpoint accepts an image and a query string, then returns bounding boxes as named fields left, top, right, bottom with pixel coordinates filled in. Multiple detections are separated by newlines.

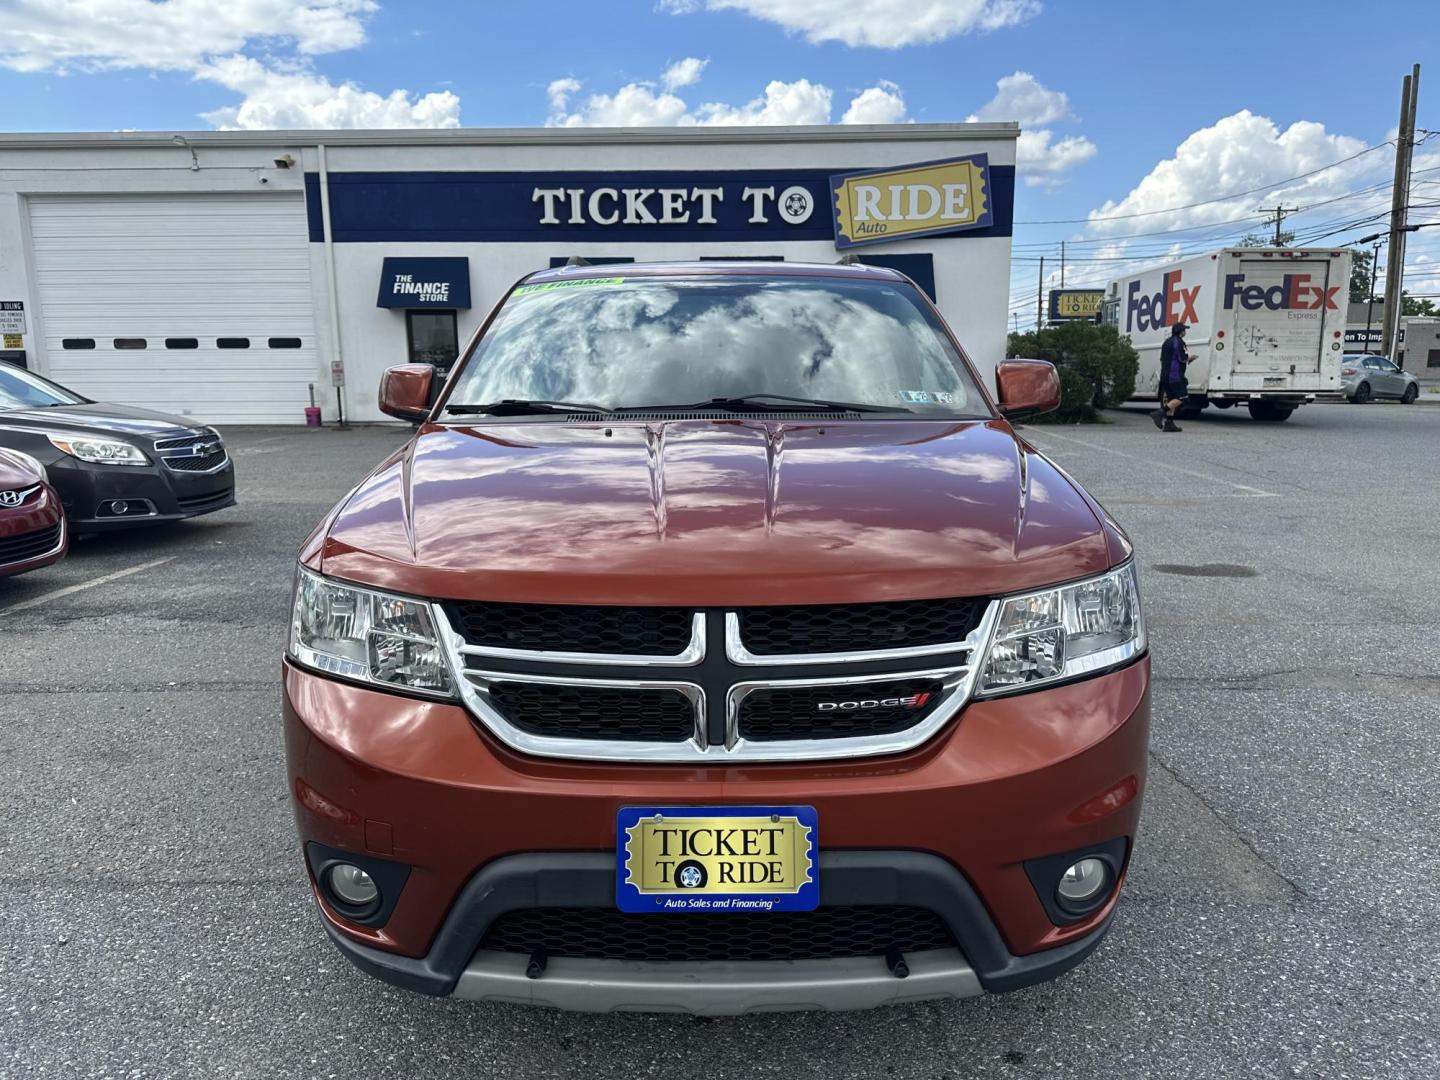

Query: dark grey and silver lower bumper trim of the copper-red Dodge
left=324, top=851, right=1110, bottom=1015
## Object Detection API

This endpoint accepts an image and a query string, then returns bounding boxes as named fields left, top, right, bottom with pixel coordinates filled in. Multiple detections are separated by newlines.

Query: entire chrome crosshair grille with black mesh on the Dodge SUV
left=433, top=598, right=996, bottom=765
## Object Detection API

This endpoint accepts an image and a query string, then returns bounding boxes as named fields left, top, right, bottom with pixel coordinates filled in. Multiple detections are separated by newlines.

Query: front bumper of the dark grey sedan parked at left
left=49, top=458, right=235, bottom=533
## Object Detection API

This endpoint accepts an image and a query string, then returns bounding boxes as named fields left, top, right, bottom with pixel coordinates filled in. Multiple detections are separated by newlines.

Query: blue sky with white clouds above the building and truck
left=0, top=0, right=1440, bottom=318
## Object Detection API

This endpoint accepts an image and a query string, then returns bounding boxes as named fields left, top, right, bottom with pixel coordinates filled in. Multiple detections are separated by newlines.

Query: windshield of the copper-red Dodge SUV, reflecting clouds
left=446, top=275, right=991, bottom=418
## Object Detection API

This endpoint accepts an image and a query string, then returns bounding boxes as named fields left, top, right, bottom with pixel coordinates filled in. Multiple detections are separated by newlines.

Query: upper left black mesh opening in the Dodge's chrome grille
left=445, top=602, right=691, bottom=657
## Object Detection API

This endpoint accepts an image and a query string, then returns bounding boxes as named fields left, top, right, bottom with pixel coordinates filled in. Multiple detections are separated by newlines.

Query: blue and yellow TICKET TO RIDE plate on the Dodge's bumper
left=615, top=806, right=819, bottom=912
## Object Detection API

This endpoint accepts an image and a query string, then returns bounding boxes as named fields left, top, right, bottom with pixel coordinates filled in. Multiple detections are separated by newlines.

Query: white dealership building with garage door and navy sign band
left=0, top=124, right=1020, bottom=425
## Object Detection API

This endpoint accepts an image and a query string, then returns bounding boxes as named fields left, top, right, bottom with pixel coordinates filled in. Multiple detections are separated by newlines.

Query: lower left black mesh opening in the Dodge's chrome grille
left=490, top=681, right=696, bottom=743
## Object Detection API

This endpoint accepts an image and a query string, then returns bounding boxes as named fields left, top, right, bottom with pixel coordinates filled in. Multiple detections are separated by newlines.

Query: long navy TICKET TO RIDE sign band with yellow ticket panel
left=305, top=154, right=1015, bottom=249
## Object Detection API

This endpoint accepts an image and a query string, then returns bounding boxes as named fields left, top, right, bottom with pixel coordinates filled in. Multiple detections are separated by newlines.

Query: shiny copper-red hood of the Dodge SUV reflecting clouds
left=318, top=420, right=1128, bottom=606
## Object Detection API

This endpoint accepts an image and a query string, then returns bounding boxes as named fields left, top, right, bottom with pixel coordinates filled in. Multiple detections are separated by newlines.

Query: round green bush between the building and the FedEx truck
left=1005, top=323, right=1140, bottom=423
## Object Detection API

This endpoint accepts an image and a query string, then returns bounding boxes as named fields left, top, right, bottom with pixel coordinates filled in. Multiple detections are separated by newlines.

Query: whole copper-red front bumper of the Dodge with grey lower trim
left=284, top=657, right=1149, bottom=1012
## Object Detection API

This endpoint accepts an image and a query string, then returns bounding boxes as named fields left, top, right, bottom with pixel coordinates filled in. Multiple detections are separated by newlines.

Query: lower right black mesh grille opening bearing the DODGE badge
left=739, top=678, right=943, bottom=742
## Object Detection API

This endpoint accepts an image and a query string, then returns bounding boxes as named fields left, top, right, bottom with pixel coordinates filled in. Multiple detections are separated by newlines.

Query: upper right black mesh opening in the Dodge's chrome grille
left=740, top=599, right=985, bottom=657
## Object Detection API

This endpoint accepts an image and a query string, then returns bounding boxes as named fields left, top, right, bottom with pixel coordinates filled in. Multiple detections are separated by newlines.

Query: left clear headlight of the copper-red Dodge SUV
left=289, top=567, right=454, bottom=697
